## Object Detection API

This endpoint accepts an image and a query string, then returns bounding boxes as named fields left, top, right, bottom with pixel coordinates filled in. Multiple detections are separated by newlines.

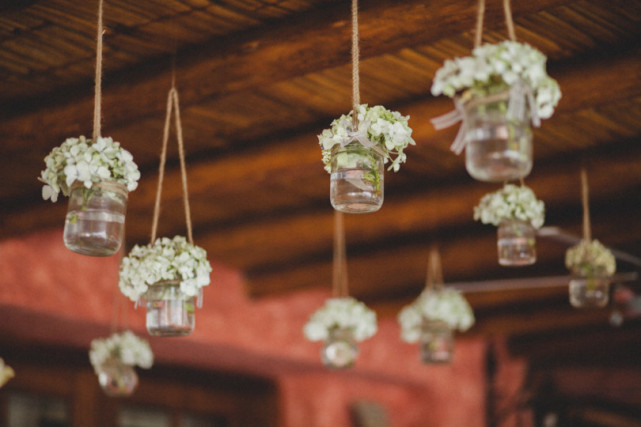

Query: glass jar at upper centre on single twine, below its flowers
left=330, top=141, right=384, bottom=213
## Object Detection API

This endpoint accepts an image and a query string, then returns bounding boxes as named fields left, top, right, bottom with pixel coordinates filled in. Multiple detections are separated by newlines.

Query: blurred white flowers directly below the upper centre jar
left=303, top=297, right=378, bottom=341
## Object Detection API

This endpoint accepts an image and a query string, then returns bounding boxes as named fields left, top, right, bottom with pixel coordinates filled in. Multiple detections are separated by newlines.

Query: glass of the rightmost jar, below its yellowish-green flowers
left=569, top=268, right=610, bottom=308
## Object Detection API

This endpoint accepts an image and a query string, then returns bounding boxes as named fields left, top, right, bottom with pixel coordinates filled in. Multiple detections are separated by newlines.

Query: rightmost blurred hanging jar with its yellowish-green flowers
left=565, top=239, right=616, bottom=308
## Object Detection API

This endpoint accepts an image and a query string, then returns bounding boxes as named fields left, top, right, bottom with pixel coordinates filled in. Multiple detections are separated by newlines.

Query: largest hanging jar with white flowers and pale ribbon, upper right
left=431, top=41, right=561, bottom=182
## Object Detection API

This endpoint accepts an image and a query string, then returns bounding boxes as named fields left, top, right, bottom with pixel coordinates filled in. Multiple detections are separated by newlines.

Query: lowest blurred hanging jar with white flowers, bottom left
left=89, top=331, right=153, bottom=397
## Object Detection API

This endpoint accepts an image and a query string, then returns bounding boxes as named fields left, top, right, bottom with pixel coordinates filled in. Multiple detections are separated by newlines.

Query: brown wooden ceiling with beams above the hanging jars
left=0, top=0, right=641, bottom=331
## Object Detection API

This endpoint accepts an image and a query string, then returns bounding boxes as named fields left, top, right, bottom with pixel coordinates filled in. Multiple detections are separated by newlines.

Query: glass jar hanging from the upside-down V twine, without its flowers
left=144, top=280, right=196, bottom=337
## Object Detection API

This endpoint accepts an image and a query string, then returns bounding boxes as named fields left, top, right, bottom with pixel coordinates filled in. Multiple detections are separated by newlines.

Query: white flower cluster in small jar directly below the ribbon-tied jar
left=474, top=184, right=545, bottom=229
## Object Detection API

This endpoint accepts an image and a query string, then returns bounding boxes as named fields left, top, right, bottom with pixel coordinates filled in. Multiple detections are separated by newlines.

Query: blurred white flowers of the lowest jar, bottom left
left=89, top=331, right=154, bottom=372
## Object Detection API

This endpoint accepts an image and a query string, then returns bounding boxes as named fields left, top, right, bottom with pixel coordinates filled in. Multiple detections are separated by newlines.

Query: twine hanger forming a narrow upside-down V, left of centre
left=151, top=84, right=194, bottom=245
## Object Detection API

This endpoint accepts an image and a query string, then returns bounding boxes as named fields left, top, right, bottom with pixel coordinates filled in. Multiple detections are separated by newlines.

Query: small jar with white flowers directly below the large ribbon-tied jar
left=474, top=184, right=545, bottom=266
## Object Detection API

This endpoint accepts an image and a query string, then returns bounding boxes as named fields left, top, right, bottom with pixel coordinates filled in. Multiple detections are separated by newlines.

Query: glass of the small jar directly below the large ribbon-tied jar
left=496, top=220, right=536, bottom=266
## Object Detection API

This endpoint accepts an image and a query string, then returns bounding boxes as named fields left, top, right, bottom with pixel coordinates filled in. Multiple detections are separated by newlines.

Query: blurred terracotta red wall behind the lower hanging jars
left=0, top=230, right=496, bottom=427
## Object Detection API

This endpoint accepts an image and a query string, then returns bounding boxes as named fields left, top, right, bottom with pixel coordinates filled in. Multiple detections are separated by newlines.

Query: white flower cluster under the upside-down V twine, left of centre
left=118, top=236, right=211, bottom=301
